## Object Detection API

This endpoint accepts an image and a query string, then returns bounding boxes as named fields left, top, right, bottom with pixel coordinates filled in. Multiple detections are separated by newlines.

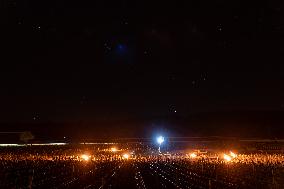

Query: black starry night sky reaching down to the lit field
left=0, top=0, right=284, bottom=137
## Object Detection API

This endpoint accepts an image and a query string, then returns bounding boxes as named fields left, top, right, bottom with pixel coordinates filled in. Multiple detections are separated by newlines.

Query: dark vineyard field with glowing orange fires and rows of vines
left=0, top=146, right=284, bottom=189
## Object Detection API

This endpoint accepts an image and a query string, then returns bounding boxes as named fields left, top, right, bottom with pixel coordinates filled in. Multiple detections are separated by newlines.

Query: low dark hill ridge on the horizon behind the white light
left=0, top=111, right=284, bottom=141
